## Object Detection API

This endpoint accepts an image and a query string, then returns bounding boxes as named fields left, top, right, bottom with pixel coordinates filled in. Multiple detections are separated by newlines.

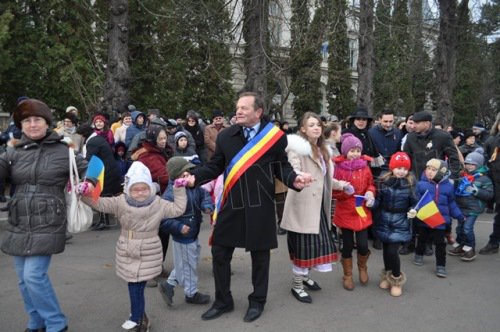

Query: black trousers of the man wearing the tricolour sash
left=212, top=245, right=271, bottom=309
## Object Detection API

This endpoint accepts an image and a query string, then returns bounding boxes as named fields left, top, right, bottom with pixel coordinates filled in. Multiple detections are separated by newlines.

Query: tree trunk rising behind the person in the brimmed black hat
left=357, top=0, right=375, bottom=114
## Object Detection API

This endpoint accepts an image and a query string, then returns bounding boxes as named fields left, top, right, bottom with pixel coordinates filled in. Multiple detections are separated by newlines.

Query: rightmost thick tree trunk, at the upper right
left=436, top=0, right=458, bottom=126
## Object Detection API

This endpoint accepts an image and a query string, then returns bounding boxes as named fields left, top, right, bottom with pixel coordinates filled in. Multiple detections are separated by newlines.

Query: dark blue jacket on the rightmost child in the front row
left=455, top=166, right=494, bottom=216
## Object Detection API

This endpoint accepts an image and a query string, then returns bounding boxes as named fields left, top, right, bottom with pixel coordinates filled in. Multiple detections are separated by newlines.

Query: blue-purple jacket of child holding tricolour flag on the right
left=417, top=172, right=464, bottom=229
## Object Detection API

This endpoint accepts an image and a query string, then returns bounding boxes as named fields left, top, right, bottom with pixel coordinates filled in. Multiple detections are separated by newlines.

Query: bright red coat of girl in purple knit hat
left=333, top=155, right=375, bottom=232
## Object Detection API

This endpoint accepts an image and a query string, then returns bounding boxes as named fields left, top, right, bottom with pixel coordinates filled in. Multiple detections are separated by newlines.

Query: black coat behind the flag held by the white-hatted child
left=85, top=135, right=122, bottom=197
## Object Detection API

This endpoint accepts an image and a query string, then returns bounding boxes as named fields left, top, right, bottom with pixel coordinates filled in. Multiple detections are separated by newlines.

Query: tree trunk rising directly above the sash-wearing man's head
left=243, top=0, right=269, bottom=109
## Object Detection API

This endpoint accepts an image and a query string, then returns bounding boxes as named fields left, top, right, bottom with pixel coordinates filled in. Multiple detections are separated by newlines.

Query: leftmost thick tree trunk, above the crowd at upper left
left=104, top=0, right=130, bottom=113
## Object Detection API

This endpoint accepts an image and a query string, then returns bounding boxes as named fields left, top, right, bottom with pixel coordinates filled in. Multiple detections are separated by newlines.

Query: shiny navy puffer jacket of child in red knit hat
left=373, top=176, right=417, bottom=243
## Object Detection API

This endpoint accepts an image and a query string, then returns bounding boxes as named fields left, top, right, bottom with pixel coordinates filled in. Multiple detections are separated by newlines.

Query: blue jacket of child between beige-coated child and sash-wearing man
left=160, top=180, right=214, bottom=243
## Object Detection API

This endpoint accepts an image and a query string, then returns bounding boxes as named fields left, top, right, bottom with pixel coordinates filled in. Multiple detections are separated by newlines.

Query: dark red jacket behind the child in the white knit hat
left=131, top=141, right=169, bottom=193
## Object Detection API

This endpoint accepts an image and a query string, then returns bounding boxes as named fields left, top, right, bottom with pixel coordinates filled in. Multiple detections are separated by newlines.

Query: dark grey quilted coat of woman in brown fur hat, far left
left=0, top=132, right=87, bottom=256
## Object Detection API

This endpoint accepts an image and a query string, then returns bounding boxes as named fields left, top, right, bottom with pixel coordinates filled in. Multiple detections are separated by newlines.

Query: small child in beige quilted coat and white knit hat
left=79, top=161, right=188, bottom=332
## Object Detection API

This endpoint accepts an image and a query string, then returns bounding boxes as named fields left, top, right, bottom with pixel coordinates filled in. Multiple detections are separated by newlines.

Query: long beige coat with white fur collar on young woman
left=281, top=135, right=342, bottom=234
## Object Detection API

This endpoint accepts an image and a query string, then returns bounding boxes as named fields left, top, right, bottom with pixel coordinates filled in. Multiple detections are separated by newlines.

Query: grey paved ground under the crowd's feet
left=0, top=214, right=500, bottom=332
